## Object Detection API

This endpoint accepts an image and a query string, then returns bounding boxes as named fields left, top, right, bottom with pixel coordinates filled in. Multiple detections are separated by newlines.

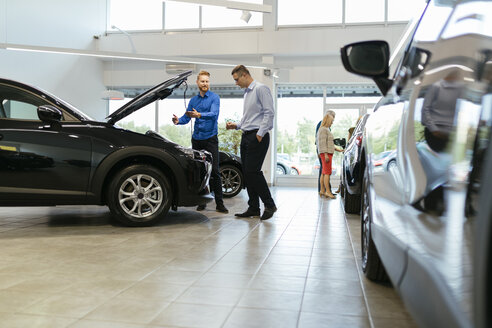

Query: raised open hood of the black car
left=106, top=71, right=191, bottom=124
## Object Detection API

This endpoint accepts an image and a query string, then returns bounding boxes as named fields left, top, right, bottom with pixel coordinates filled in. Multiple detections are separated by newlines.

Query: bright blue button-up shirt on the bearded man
left=178, top=90, right=220, bottom=140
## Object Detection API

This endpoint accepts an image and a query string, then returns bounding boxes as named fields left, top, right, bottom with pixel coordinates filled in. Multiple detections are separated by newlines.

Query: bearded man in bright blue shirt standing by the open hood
left=173, top=71, right=229, bottom=213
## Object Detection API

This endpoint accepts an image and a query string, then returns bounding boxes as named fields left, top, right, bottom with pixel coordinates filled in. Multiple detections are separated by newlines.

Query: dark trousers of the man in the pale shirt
left=241, top=131, right=275, bottom=211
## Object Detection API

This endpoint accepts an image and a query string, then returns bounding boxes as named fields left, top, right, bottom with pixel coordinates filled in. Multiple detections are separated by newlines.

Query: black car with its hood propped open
left=0, top=71, right=212, bottom=226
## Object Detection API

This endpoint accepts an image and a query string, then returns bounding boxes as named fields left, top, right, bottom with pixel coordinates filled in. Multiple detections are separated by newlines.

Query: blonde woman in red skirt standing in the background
left=318, top=113, right=335, bottom=199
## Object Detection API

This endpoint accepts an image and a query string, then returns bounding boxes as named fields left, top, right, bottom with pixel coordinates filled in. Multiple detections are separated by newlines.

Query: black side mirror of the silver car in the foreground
left=340, top=41, right=393, bottom=95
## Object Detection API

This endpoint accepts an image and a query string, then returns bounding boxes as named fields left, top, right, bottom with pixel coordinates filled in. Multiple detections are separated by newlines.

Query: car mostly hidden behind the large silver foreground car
left=340, top=114, right=369, bottom=214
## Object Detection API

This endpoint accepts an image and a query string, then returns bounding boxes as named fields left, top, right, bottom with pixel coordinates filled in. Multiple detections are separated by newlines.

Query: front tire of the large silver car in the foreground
left=360, top=170, right=389, bottom=282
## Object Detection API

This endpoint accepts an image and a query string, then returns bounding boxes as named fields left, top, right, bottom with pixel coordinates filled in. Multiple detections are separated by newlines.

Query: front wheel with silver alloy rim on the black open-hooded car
left=106, top=164, right=172, bottom=227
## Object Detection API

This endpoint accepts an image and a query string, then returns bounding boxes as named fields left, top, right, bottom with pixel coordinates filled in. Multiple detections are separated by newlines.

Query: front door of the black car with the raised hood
left=0, top=83, right=91, bottom=205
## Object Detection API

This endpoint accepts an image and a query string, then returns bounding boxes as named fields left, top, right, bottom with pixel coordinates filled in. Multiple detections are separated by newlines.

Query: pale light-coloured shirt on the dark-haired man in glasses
left=237, top=81, right=275, bottom=137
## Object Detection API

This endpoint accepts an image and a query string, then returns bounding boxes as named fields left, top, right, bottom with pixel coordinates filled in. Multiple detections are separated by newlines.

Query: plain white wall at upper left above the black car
left=0, top=0, right=107, bottom=119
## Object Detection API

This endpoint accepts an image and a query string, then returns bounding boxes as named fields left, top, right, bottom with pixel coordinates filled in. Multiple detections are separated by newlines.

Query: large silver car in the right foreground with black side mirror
left=342, top=0, right=492, bottom=327
